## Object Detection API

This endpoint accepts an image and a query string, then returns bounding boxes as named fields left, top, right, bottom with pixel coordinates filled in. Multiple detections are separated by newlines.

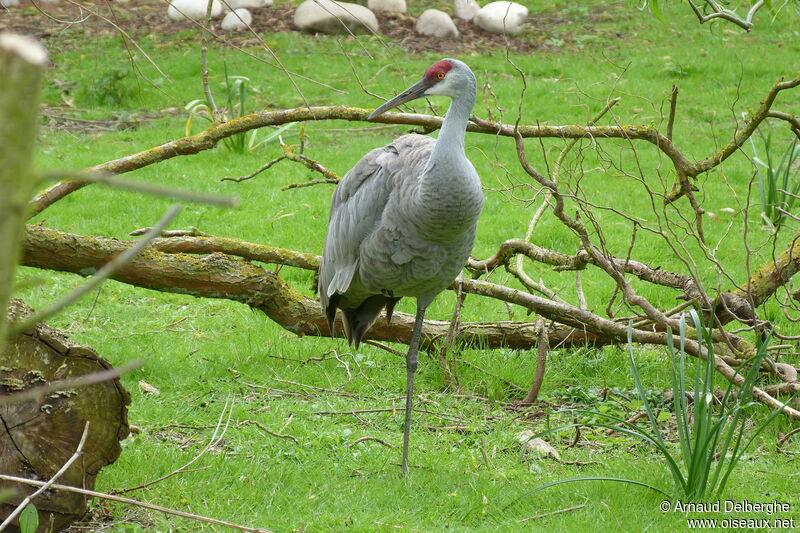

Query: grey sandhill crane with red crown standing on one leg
left=319, top=59, right=483, bottom=474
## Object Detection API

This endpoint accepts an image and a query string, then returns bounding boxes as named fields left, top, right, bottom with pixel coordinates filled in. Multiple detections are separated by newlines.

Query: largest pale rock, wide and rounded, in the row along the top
left=294, top=0, right=378, bottom=33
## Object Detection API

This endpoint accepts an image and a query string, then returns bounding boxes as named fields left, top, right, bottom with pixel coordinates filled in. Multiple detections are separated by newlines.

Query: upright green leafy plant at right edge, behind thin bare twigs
left=750, top=130, right=800, bottom=228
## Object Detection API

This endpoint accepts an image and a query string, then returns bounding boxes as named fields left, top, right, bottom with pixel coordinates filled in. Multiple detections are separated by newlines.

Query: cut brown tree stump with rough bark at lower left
left=0, top=300, right=130, bottom=532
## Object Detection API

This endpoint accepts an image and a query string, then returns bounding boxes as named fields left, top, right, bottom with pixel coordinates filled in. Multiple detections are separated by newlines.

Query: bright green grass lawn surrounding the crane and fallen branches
left=10, top=2, right=800, bottom=531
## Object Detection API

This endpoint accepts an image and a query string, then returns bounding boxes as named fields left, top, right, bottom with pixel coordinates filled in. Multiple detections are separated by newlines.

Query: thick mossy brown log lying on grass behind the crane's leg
left=23, top=226, right=613, bottom=349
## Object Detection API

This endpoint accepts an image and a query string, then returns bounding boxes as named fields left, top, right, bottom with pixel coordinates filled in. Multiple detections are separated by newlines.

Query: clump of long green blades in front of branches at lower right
left=507, top=311, right=783, bottom=507
